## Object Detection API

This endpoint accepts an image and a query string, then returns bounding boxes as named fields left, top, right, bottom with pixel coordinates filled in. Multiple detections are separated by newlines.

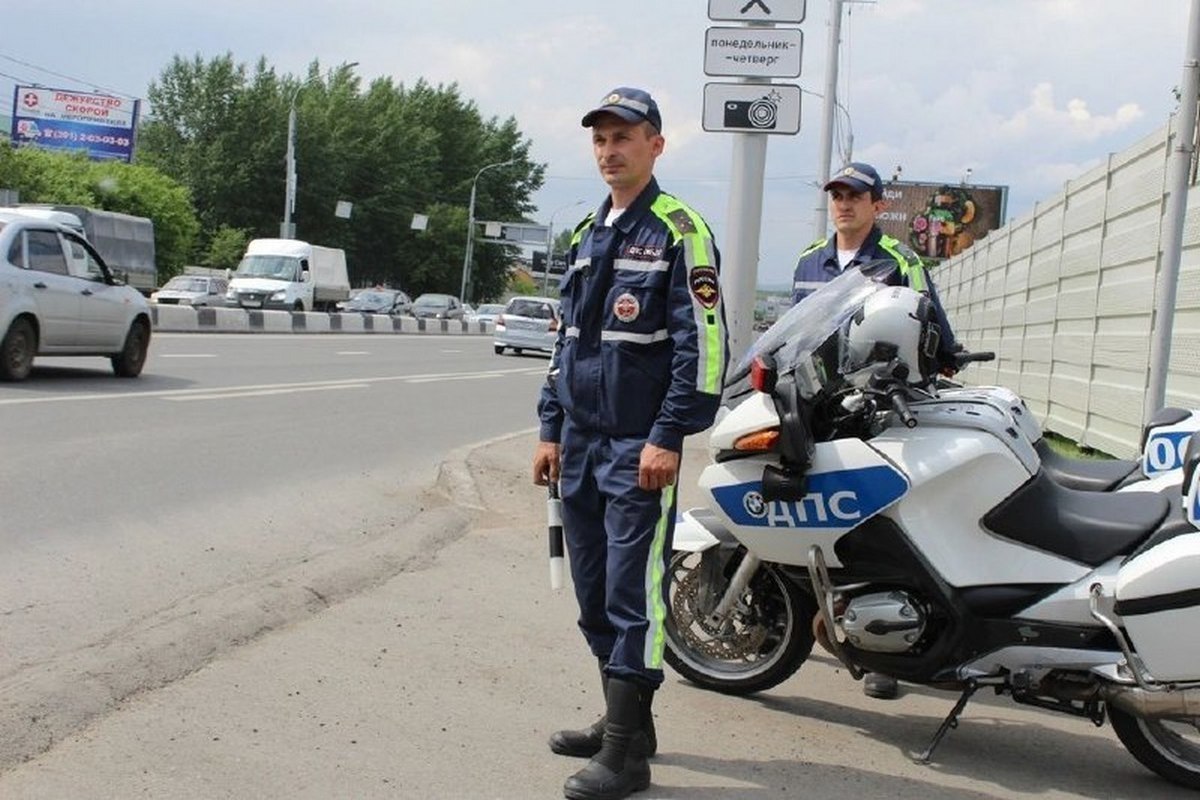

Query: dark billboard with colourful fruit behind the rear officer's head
left=877, top=181, right=1008, bottom=259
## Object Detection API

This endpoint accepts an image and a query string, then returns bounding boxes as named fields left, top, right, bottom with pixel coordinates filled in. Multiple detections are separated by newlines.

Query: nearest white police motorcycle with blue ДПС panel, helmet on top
left=665, top=265, right=1200, bottom=788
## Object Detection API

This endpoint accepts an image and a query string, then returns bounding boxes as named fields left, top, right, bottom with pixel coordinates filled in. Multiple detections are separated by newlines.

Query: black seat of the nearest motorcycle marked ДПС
left=983, top=469, right=1171, bottom=566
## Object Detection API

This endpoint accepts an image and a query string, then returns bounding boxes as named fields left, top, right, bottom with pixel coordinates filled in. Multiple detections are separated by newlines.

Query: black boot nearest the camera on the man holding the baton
left=563, top=678, right=650, bottom=800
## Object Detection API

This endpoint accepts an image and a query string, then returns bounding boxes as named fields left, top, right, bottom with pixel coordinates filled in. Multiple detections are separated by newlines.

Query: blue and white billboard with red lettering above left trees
left=12, top=86, right=139, bottom=161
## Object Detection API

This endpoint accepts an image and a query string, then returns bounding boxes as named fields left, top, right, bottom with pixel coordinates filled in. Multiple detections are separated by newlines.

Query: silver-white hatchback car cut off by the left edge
left=0, top=211, right=150, bottom=380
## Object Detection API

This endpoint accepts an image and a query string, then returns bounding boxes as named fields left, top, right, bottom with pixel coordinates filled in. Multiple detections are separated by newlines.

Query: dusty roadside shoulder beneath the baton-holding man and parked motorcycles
left=0, top=434, right=1195, bottom=800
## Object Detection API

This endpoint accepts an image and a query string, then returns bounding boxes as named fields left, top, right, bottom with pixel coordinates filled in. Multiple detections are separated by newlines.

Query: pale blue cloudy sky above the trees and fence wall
left=0, top=0, right=1189, bottom=285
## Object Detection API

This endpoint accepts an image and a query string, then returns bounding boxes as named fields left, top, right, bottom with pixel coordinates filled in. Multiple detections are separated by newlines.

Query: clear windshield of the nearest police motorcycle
left=727, top=260, right=896, bottom=385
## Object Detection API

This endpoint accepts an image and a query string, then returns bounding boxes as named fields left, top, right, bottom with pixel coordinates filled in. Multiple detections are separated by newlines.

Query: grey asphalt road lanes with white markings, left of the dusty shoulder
left=0, top=333, right=547, bottom=766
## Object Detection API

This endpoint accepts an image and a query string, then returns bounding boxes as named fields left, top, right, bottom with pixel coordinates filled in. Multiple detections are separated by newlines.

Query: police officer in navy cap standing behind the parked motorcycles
left=792, top=162, right=958, bottom=700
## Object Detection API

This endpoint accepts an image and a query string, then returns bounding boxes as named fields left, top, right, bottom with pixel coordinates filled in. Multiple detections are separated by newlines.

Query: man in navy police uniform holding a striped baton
left=533, top=86, right=728, bottom=800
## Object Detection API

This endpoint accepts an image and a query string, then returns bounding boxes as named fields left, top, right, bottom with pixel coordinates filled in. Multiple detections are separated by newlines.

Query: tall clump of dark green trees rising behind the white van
left=139, top=54, right=545, bottom=296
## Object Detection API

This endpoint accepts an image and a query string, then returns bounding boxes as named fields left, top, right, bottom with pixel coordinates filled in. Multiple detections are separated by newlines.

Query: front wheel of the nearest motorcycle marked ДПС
left=664, top=549, right=816, bottom=694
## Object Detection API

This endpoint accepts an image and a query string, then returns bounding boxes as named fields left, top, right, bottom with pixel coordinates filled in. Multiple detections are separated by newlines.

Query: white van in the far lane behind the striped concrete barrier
left=226, top=239, right=350, bottom=311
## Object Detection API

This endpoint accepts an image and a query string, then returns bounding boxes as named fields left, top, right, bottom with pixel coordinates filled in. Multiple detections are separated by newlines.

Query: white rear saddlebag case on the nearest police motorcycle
left=1114, top=530, right=1200, bottom=681
